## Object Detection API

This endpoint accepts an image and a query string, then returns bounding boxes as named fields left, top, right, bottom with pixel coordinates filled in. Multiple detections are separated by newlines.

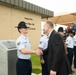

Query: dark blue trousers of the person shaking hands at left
left=16, top=59, right=32, bottom=75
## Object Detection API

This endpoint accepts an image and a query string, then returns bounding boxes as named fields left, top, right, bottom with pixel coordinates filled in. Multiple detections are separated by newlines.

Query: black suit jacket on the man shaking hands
left=43, top=30, right=71, bottom=75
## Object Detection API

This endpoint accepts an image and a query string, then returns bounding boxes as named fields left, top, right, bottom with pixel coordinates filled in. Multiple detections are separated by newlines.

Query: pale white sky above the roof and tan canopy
left=25, top=0, right=76, bottom=15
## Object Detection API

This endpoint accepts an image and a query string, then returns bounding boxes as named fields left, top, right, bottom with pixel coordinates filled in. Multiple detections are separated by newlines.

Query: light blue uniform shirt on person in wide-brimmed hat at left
left=16, top=35, right=31, bottom=59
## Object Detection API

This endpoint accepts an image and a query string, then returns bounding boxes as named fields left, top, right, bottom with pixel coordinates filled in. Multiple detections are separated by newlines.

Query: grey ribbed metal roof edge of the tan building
left=0, top=0, right=54, bottom=18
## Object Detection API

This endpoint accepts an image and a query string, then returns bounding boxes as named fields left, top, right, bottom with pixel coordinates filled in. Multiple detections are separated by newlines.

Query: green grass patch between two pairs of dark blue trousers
left=31, top=54, right=41, bottom=74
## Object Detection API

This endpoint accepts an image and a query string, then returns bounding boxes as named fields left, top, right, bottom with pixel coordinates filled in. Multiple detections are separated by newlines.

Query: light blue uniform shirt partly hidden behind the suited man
left=39, top=35, right=48, bottom=50
